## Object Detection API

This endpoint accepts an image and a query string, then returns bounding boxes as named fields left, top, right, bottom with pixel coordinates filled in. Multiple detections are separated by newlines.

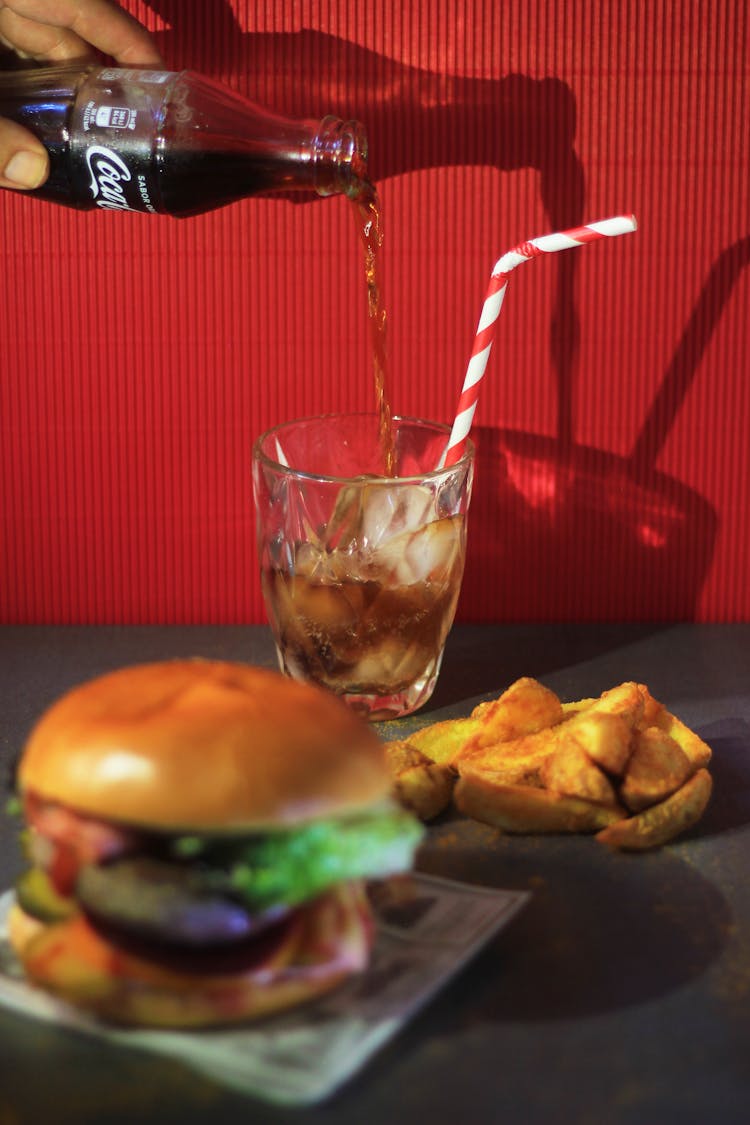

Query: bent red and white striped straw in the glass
left=441, top=215, right=636, bottom=468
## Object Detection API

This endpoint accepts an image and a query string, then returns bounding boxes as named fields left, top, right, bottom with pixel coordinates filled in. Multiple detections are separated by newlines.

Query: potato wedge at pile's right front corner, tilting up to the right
left=596, top=768, right=712, bottom=852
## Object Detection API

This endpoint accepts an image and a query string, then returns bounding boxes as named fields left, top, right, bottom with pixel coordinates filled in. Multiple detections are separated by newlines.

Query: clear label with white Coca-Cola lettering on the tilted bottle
left=71, top=68, right=174, bottom=214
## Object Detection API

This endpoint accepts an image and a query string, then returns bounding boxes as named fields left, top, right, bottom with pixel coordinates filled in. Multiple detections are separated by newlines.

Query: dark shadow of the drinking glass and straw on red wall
left=460, top=237, right=750, bottom=621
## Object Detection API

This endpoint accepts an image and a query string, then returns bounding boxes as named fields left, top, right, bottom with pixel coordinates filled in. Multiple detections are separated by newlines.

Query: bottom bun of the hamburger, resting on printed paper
left=8, top=883, right=373, bottom=1028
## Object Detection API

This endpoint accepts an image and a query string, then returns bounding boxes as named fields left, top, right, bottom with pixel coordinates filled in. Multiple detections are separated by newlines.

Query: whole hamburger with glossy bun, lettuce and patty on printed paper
left=8, top=659, right=422, bottom=1027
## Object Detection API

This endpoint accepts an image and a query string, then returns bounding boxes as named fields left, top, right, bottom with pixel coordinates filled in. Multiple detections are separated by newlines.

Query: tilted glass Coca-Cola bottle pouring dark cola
left=0, top=63, right=368, bottom=216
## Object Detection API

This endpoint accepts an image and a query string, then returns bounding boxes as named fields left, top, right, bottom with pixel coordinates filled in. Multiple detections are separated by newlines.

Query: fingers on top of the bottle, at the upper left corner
left=0, top=0, right=163, bottom=66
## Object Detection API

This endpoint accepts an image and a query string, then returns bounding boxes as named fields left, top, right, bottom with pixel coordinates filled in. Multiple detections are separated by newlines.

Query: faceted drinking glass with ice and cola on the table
left=253, top=414, right=473, bottom=720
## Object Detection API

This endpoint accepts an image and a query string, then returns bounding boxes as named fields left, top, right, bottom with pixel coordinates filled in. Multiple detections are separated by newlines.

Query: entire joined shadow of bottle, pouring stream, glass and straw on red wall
left=145, top=0, right=750, bottom=621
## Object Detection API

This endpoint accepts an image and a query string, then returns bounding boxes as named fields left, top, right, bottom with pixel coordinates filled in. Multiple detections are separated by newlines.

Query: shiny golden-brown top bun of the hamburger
left=18, top=659, right=390, bottom=833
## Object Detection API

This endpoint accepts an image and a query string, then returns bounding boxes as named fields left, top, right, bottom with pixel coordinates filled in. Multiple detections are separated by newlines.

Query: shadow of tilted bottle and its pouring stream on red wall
left=150, top=0, right=591, bottom=444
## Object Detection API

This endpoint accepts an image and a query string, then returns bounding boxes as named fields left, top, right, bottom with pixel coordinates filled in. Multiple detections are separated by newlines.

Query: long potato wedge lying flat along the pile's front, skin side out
left=454, top=770, right=623, bottom=834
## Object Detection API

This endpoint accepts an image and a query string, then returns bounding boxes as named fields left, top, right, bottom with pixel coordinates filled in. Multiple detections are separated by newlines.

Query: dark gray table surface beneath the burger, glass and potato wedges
left=0, top=624, right=750, bottom=1125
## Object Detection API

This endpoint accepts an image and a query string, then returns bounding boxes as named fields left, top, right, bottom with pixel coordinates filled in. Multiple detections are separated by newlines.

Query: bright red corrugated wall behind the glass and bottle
left=0, top=0, right=750, bottom=622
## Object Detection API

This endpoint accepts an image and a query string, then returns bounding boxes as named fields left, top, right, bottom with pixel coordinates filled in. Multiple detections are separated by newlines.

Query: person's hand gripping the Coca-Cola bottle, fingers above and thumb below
left=0, top=0, right=163, bottom=188
